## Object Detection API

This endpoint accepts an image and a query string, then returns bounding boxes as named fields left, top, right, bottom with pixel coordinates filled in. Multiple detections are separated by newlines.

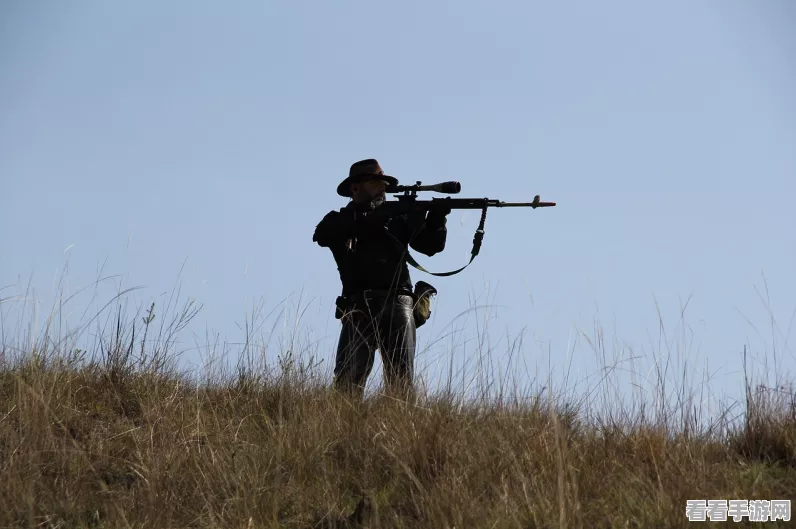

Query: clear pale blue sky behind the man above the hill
left=0, top=0, right=796, bottom=410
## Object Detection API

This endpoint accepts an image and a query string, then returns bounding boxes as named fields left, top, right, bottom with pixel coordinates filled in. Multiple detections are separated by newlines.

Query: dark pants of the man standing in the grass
left=334, top=294, right=416, bottom=398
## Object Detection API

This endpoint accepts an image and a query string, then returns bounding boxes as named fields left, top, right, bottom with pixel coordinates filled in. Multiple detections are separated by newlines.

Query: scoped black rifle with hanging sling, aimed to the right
left=364, top=181, right=556, bottom=276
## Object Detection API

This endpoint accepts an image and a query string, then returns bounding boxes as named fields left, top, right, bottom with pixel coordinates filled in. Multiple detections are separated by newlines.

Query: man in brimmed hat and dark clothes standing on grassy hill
left=312, top=159, right=450, bottom=398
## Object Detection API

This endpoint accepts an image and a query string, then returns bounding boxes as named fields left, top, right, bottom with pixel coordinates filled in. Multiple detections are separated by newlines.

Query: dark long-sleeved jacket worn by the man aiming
left=312, top=202, right=448, bottom=295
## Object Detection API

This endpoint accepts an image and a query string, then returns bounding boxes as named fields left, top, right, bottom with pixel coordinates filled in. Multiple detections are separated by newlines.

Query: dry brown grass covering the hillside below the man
left=0, top=286, right=796, bottom=529
